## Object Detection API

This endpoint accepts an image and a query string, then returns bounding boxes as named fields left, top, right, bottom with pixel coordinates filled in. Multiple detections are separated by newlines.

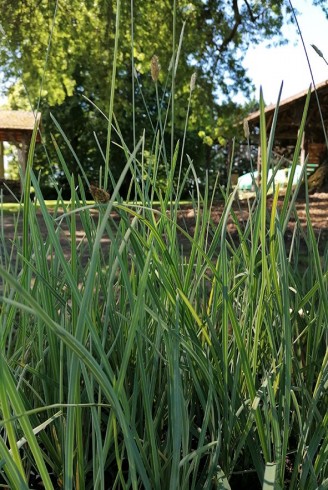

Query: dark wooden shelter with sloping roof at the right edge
left=246, top=80, right=328, bottom=178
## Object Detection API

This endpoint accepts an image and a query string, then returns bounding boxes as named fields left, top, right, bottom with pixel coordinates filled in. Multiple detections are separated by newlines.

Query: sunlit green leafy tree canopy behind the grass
left=0, top=0, right=328, bottom=193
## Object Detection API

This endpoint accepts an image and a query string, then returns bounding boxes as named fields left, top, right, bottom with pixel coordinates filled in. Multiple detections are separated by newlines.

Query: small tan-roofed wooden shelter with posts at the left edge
left=0, top=111, right=41, bottom=195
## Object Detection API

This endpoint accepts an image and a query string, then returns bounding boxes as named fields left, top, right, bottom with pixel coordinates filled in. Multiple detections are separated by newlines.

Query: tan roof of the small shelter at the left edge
left=0, top=111, right=41, bottom=143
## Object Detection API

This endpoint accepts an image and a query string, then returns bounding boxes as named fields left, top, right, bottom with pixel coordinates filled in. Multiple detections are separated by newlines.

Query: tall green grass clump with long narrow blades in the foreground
left=0, top=9, right=328, bottom=490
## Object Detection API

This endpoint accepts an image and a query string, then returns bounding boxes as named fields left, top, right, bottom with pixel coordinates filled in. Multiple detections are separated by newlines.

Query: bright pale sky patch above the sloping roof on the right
left=238, top=0, right=328, bottom=104
